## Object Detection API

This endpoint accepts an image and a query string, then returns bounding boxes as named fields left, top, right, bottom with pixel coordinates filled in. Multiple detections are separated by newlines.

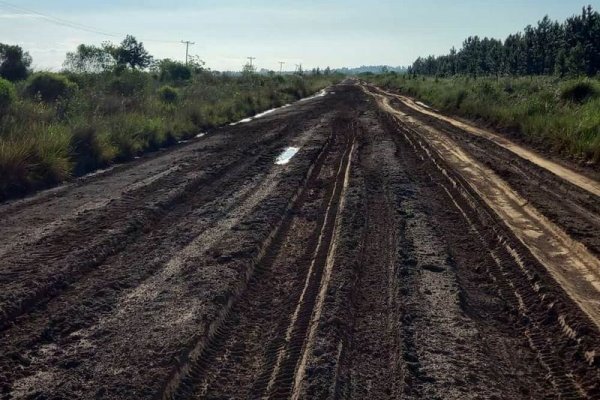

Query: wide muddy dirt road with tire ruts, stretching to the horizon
left=0, top=81, right=600, bottom=399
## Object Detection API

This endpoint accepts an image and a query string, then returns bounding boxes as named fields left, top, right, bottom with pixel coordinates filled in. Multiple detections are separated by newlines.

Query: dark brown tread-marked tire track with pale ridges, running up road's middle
left=163, top=112, right=352, bottom=399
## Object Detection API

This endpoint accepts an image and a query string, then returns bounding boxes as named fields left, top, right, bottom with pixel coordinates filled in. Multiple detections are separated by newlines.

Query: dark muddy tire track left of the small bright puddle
left=0, top=104, right=324, bottom=331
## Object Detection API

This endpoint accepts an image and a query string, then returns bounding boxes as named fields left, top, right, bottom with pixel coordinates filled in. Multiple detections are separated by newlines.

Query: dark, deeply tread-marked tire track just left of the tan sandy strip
left=384, top=111, right=600, bottom=399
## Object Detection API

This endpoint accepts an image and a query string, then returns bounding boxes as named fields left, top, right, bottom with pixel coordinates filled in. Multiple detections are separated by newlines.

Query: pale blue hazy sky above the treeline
left=0, top=0, right=600, bottom=70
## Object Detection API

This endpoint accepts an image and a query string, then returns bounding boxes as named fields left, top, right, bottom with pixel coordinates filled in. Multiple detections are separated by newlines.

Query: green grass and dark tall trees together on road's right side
left=376, top=6, right=600, bottom=165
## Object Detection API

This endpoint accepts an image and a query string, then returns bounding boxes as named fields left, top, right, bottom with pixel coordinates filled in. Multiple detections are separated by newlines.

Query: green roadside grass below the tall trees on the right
left=363, top=74, right=600, bottom=167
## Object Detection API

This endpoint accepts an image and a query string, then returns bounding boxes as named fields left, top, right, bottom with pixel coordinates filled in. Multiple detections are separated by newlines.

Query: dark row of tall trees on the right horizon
left=409, top=6, right=600, bottom=77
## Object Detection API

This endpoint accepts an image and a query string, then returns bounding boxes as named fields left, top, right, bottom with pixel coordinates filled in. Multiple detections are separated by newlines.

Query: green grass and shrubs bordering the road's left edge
left=0, top=71, right=340, bottom=201
